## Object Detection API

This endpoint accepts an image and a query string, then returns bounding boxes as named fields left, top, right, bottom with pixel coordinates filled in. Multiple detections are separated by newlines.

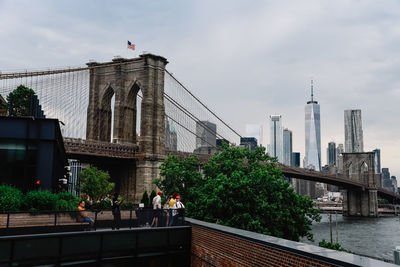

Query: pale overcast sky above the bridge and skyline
left=0, top=0, right=400, bottom=176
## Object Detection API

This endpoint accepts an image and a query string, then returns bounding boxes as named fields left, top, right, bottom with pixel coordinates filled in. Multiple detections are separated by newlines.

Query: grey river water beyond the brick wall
left=301, top=214, right=400, bottom=261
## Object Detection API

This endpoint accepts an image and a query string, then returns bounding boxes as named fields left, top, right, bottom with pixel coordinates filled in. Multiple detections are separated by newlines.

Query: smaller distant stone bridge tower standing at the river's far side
left=341, top=152, right=381, bottom=217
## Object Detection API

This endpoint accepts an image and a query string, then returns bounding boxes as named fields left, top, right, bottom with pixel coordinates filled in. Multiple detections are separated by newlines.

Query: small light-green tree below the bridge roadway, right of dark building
left=79, top=166, right=114, bottom=202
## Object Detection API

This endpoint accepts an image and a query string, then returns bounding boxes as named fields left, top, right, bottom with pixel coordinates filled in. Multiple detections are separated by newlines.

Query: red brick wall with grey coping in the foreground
left=186, top=218, right=395, bottom=267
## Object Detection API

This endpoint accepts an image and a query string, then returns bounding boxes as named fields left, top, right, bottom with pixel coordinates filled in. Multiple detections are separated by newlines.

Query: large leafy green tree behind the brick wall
left=155, top=145, right=320, bottom=241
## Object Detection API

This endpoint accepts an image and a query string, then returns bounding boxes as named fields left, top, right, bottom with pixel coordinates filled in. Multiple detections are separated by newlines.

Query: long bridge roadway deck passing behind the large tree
left=64, top=138, right=400, bottom=201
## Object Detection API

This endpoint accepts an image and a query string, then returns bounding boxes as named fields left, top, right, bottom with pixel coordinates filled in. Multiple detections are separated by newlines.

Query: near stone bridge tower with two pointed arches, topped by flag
left=86, top=54, right=168, bottom=203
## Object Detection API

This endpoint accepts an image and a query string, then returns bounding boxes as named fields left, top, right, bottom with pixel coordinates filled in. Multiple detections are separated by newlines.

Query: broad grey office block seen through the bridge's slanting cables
left=194, top=121, right=217, bottom=154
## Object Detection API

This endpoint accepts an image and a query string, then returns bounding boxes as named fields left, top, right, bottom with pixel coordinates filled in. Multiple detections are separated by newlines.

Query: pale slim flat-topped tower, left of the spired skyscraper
left=268, top=115, right=282, bottom=162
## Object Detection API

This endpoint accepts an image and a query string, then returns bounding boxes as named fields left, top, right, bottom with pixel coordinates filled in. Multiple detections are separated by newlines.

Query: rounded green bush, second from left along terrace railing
left=24, top=191, right=57, bottom=211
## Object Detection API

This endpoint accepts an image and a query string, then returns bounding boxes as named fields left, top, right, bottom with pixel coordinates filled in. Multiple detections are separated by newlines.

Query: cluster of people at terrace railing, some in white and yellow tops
left=151, top=191, right=185, bottom=227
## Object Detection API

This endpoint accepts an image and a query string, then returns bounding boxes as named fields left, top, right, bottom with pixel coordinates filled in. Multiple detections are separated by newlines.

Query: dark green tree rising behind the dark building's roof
left=5, top=84, right=35, bottom=116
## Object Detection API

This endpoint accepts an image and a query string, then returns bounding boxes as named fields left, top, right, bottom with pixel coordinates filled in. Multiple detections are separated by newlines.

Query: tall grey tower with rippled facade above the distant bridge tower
left=344, top=109, right=364, bottom=153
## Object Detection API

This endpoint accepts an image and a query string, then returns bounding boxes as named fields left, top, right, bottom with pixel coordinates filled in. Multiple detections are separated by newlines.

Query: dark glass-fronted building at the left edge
left=0, top=117, right=68, bottom=191
